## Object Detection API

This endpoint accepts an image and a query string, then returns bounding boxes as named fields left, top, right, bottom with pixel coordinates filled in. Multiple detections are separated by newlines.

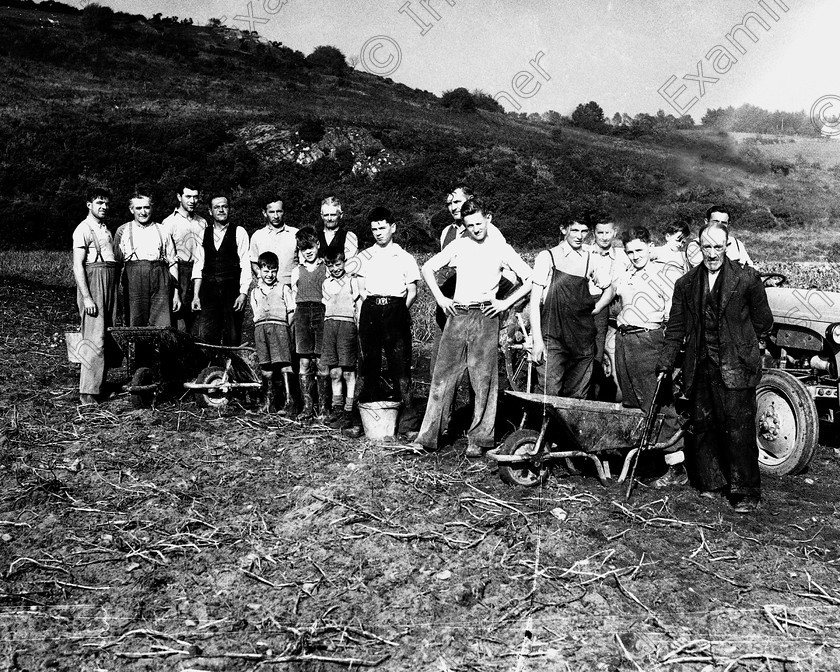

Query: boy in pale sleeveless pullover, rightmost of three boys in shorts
left=321, top=249, right=359, bottom=429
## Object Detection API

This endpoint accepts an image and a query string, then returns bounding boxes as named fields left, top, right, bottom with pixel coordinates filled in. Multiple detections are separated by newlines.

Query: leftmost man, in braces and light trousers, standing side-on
left=73, top=188, right=118, bottom=406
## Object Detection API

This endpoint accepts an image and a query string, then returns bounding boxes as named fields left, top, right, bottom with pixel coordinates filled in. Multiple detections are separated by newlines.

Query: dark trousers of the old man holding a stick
left=686, top=358, right=761, bottom=497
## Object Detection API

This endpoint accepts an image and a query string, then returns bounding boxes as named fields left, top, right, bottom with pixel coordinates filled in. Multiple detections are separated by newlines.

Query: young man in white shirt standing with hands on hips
left=415, top=198, right=531, bottom=457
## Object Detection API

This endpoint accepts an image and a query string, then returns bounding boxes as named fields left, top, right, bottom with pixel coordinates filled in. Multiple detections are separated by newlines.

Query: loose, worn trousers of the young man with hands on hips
left=417, top=310, right=499, bottom=448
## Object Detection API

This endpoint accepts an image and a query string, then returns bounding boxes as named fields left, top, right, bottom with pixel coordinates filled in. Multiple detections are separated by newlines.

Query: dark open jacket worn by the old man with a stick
left=657, top=259, right=773, bottom=393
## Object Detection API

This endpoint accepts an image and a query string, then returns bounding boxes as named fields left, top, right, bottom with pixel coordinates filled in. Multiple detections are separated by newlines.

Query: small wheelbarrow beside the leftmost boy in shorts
left=184, top=343, right=262, bottom=408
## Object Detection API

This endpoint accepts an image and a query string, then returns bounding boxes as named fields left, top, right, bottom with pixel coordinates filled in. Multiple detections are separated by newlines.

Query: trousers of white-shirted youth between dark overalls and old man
left=615, top=329, right=682, bottom=453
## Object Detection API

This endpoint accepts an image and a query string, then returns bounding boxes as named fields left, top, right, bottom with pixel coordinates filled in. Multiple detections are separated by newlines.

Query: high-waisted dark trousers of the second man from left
left=125, top=261, right=172, bottom=327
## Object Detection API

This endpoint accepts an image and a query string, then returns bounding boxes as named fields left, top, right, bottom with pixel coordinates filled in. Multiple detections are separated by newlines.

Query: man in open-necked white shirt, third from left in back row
left=161, top=179, right=207, bottom=334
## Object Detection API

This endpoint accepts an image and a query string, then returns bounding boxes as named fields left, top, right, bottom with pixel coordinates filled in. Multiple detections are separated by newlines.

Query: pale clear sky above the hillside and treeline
left=88, top=0, right=840, bottom=122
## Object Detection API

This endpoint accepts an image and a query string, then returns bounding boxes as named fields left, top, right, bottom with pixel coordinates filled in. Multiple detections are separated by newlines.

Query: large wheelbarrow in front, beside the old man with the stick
left=487, top=390, right=684, bottom=487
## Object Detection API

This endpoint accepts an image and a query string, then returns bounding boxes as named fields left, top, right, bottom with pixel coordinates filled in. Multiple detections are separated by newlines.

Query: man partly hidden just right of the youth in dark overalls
left=584, top=220, right=630, bottom=401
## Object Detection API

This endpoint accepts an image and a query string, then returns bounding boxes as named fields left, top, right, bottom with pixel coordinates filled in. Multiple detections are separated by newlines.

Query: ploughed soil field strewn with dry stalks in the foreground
left=0, top=279, right=840, bottom=672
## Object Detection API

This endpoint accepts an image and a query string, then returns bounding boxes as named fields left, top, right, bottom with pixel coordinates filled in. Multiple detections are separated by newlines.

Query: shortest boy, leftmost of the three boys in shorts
left=251, top=252, right=295, bottom=415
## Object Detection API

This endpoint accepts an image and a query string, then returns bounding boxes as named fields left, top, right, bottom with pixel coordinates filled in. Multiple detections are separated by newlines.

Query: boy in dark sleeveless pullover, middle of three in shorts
left=291, top=226, right=330, bottom=421
